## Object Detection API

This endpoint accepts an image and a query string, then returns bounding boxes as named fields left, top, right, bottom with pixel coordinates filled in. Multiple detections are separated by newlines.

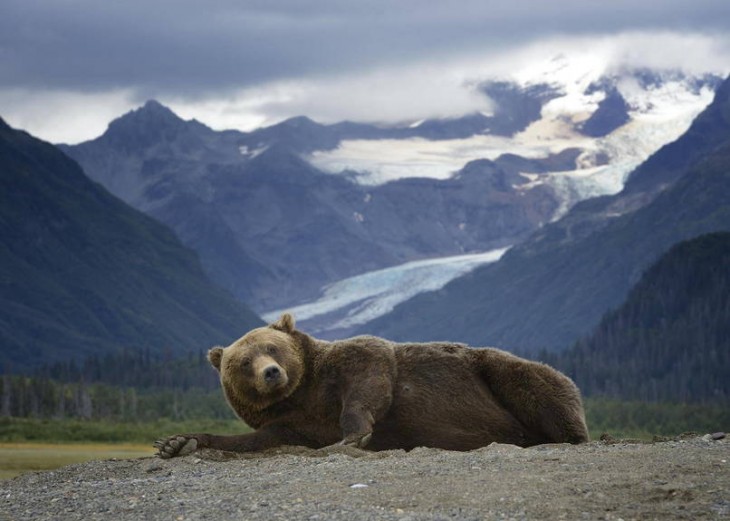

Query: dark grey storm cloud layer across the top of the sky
left=0, top=0, right=730, bottom=95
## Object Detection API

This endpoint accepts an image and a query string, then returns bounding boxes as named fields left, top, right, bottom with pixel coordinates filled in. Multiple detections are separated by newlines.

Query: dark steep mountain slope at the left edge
left=0, top=120, right=261, bottom=371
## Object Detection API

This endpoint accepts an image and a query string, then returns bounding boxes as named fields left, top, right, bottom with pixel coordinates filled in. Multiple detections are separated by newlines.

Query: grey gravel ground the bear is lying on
left=0, top=435, right=730, bottom=521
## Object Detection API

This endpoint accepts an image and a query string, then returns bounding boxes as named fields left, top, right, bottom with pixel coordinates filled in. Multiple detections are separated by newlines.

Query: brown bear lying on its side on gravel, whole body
left=155, top=314, right=588, bottom=458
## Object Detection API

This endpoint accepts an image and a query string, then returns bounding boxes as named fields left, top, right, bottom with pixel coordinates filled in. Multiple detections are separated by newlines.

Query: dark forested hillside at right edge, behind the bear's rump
left=547, top=233, right=730, bottom=403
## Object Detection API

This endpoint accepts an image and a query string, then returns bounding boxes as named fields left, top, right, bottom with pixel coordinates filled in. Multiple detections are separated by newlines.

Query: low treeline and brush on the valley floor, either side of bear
left=0, top=375, right=730, bottom=441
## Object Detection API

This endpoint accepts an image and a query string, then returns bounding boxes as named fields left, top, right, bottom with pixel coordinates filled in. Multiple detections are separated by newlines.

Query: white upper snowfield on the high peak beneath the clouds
left=307, top=56, right=714, bottom=220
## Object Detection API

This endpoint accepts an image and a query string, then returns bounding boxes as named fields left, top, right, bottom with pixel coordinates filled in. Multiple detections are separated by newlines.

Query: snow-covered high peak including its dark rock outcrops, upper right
left=308, top=59, right=721, bottom=218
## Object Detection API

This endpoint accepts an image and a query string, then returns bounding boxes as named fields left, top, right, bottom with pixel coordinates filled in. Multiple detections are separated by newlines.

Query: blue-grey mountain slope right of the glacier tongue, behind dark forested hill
left=362, top=75, right=730, bottom=352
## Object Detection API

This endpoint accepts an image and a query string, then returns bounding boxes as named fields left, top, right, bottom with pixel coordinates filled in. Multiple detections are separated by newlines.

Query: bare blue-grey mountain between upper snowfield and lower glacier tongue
left=62, top=102, right=570, bottom=311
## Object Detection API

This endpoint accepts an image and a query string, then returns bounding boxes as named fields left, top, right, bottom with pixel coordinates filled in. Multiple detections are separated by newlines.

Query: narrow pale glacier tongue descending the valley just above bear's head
left=263, top=248, right=508, bottom=333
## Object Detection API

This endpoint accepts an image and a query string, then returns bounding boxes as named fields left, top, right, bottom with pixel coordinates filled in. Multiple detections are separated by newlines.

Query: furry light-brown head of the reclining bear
left=208, top=313, right=304, bottom=416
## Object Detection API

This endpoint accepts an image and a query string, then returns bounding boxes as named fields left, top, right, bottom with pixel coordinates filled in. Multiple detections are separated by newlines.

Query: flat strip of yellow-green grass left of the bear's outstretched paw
left=0, top=443, right=154, bottom=480
